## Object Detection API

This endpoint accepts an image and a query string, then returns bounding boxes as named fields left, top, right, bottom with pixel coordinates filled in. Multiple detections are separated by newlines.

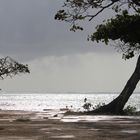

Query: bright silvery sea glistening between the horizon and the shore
left=0, top=92, right=140, bottom=112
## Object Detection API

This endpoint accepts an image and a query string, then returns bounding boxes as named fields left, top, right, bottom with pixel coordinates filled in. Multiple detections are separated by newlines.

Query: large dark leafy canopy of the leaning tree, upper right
left=55, top=0, right=140, bottom=59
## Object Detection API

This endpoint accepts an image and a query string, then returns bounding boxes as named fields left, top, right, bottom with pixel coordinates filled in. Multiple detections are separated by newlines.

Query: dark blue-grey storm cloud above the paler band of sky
left=0, top=0, right=114, bottom=60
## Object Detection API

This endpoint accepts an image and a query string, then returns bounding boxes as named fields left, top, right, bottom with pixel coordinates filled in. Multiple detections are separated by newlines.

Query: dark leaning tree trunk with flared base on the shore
left=93, top=56, right=140, bottom=114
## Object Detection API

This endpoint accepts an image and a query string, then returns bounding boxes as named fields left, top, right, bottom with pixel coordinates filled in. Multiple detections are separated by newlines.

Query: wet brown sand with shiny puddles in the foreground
left=0, top=110, right=140, bottom=140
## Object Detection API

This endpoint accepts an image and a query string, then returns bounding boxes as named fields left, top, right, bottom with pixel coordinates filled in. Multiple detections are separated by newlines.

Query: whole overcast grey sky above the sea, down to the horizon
left=0, top=0, right=140, bottom=92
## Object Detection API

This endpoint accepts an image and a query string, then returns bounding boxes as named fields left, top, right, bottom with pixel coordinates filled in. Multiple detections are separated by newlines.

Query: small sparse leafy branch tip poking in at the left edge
left=0, top=56, right=30, bottom=79
